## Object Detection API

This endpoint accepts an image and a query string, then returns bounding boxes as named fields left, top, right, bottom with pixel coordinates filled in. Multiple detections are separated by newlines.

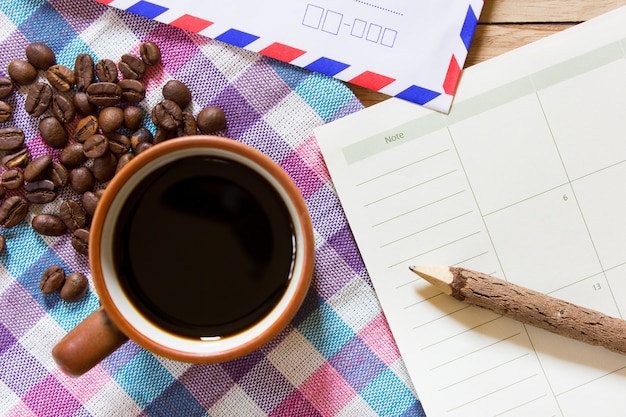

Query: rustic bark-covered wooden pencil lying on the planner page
left=409, top=266, right=626, bottom=354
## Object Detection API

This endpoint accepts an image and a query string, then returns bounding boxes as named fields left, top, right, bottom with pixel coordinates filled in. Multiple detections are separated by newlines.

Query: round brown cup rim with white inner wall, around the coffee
left=89, top=136, right=314, bottom=363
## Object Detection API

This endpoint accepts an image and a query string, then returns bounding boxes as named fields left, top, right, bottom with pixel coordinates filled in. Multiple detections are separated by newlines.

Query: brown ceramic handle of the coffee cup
left=52, top=307, right=128, bottom=376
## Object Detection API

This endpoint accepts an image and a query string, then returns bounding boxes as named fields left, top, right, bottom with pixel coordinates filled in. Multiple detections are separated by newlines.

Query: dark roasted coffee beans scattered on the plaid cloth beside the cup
left=0, top=42, right=226, bottom=301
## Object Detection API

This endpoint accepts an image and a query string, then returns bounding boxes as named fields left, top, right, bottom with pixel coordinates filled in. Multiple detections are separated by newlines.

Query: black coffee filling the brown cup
left=114, top=156, right=295, bottom=338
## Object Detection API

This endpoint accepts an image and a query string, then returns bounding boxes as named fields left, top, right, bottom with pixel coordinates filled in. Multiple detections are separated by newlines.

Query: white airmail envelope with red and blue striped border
left=97, top=0, right=483, bottom=112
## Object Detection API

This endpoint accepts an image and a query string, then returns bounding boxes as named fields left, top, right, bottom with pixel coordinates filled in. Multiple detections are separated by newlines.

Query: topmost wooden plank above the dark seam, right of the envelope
left=480, top=0, right=626, bottom=23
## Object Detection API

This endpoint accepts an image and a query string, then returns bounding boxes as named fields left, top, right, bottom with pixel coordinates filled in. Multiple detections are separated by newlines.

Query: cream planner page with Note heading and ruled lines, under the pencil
left=316, top=8, right=626, bottom=417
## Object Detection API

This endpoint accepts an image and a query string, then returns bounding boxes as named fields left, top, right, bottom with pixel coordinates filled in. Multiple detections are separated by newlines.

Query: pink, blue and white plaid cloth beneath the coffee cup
left=0, top=0, right=424, bottom=417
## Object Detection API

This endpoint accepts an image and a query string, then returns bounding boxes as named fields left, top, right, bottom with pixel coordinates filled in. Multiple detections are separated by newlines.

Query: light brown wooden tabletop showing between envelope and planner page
left=348, top=0, right=626, bottom=107
